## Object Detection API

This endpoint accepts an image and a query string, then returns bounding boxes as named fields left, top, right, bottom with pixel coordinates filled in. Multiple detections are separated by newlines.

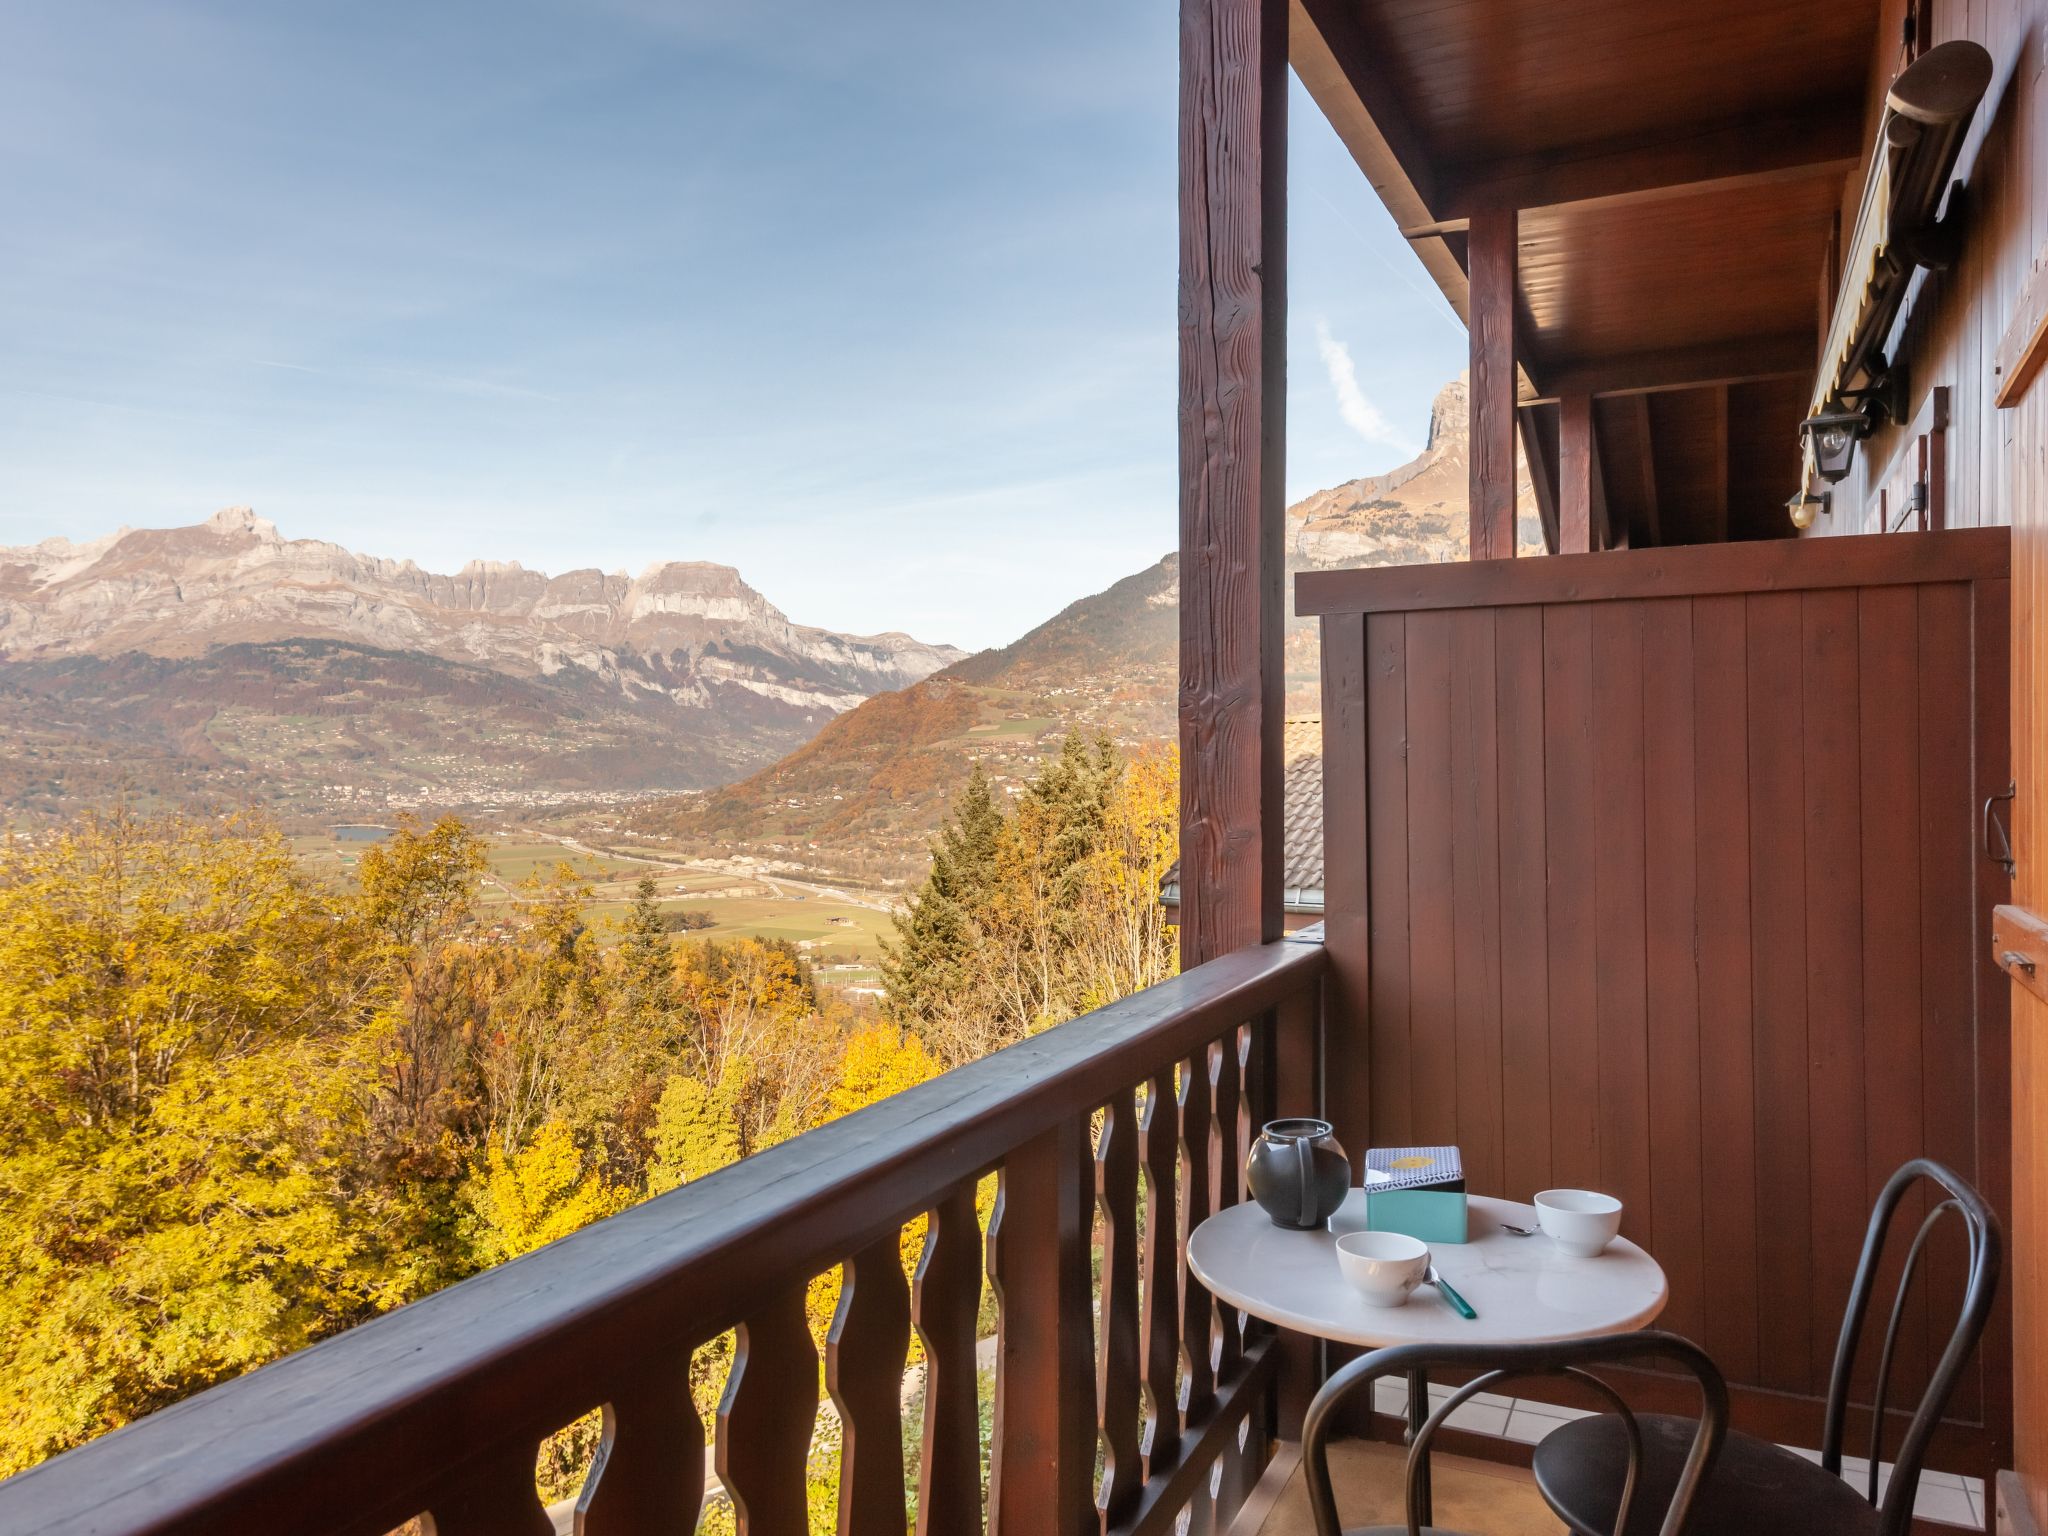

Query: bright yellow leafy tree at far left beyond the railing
left=0, top=813, right=412, bottom=1473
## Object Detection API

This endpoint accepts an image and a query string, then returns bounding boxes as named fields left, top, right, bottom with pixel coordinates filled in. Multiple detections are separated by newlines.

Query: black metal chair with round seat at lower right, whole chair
left=1534, top=1157, right=1999, bottom=1536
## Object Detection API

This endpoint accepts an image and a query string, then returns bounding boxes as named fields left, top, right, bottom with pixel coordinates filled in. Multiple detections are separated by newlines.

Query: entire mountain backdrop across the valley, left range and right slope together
left=0, top=381, right=1536, bottom=887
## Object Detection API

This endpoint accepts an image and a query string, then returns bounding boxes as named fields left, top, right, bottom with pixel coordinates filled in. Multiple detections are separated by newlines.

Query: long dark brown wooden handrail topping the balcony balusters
left=0, top=934, right=1323, bottom=1536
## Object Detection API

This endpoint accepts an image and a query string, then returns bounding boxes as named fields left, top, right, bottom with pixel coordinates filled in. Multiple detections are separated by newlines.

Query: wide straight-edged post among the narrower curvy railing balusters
left=989, top=1118, right=1100, bottom=1536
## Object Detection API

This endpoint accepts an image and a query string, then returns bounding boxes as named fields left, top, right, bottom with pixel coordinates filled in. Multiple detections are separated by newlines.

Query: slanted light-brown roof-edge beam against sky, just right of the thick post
left=1288, top=0, right=1466, bottom=319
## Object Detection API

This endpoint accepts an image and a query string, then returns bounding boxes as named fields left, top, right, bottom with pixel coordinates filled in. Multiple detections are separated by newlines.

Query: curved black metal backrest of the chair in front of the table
left=1300, top=1331, right=1729, bottom=1536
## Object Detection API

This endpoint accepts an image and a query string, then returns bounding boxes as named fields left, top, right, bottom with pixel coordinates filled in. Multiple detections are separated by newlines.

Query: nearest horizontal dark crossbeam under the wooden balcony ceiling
left=1432, top=102, right=1864, bottom=219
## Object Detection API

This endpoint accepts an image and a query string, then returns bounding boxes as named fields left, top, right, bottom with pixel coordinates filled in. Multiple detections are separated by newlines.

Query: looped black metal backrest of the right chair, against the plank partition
left=1821, top=1157, right=2003, bottom=1536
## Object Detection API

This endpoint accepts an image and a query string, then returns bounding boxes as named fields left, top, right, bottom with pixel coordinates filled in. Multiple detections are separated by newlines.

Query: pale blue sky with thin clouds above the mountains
left=0, top=0, right=1464, bottom=647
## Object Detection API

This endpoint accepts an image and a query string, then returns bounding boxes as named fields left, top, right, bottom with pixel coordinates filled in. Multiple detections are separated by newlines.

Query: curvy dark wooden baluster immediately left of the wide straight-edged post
left=911, top=1180, right=981, bottom=1536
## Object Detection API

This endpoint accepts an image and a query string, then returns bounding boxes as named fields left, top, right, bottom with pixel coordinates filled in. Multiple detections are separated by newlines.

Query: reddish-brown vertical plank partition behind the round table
left=1300, top=528, right=2011, bottom=1475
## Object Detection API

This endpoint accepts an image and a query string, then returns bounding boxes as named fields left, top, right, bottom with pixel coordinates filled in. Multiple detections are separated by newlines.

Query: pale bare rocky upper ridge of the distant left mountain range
left=0, top=506, right=961, bottom=720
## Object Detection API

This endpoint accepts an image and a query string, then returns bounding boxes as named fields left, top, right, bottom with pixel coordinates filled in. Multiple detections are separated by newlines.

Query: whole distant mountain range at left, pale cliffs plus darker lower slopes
left=0, top=508, right=963, bottom=811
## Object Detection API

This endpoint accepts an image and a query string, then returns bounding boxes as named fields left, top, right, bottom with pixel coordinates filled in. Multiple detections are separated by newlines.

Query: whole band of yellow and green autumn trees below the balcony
left=0, top=737, right=1176, bottom=1495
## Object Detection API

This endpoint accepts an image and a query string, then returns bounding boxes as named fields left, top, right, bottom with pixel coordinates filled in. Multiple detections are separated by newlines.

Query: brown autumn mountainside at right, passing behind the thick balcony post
left=629, top=379, right=1542, bottom=879
